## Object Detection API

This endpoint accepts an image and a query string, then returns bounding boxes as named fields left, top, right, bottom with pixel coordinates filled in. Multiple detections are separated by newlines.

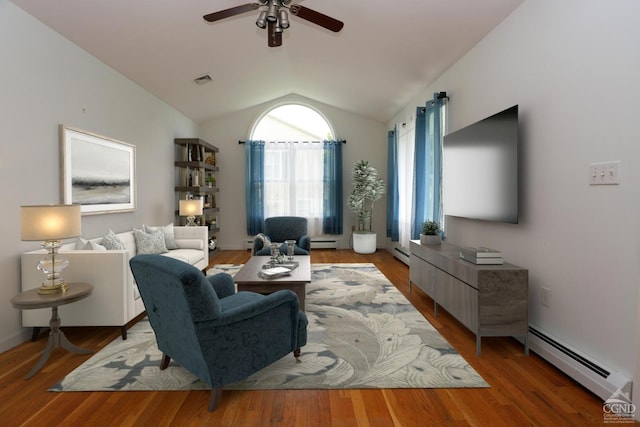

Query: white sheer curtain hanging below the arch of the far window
left=264, top=142, right=324, bottom=236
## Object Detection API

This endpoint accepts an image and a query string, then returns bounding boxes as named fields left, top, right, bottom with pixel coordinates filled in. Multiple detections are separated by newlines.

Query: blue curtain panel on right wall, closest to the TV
left=411, top=92, right=447, bottom=239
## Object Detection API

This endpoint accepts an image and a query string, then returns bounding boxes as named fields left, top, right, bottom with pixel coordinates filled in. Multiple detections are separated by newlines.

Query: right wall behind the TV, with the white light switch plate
left=388, top=0, right=640, bottom=392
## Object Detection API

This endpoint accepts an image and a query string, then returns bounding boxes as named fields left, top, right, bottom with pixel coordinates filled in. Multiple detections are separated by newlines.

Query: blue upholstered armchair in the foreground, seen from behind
left=130, top=255, right=307, bottom=411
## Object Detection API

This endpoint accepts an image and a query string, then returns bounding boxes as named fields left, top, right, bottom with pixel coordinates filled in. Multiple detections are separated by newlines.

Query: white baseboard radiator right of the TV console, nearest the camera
left=529, top=326, right=632, bottom=401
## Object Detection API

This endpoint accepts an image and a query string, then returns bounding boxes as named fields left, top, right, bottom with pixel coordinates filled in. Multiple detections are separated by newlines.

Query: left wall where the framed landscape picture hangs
left=0, top=0, right=198, bottom=351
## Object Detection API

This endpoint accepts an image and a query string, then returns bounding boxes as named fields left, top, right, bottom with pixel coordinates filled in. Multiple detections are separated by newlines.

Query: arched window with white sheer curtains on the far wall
left=250, top=104, right=333, bottom=236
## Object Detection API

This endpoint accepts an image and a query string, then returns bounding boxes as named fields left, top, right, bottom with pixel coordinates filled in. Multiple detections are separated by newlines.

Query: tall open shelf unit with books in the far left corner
left=174, top=138, right=220, bottom=253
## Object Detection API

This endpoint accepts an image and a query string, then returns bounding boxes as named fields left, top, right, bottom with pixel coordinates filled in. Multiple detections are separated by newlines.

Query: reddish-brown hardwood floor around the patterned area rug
left=0, top=250, right=603, bottom=427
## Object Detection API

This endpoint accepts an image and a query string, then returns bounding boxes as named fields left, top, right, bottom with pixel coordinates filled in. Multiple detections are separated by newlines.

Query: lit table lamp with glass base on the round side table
left=20, top=205, right=82, bottom=295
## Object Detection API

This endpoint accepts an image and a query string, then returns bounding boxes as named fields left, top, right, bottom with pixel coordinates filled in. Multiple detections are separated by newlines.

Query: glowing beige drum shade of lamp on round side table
left=20, top=205, right=82, bottom=241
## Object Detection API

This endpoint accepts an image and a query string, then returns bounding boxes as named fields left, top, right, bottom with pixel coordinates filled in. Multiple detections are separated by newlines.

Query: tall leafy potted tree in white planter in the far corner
left=349, top=160, right=384, bottom=254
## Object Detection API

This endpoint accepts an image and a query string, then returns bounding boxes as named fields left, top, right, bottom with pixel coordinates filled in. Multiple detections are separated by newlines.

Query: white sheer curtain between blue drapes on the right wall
left=397, top=120, right=416, bottom=250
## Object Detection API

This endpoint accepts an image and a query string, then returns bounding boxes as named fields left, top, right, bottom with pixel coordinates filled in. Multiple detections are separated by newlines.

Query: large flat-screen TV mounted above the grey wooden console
left=442, top=105, right=518, bottom=224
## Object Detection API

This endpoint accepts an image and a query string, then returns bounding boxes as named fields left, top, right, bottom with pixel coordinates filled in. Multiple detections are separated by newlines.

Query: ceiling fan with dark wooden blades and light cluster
left=203, top=0, right=344, bottom=47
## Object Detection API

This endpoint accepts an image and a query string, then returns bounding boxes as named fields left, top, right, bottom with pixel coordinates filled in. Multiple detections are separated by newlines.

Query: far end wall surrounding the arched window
left=201, top=94, right=387, bottom=249
